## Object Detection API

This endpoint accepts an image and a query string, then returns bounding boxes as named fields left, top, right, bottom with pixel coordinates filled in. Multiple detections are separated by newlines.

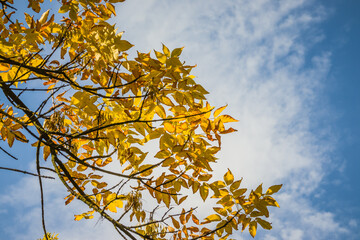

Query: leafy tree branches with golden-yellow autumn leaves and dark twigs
left=0, top=0, right=281, bottom=240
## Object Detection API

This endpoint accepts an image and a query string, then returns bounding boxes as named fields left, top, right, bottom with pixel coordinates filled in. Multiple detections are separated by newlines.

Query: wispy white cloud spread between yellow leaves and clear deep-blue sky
left=0, top=0, right=357, bottom=240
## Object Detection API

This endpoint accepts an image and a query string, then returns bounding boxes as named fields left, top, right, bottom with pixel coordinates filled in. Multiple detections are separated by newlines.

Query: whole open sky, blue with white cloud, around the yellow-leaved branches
left=0, top=0, right=360, bottom=240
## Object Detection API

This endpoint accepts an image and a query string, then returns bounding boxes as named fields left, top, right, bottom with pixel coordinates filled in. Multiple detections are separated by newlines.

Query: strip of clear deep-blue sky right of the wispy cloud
left=314, top=1, right=360, bottom=229
